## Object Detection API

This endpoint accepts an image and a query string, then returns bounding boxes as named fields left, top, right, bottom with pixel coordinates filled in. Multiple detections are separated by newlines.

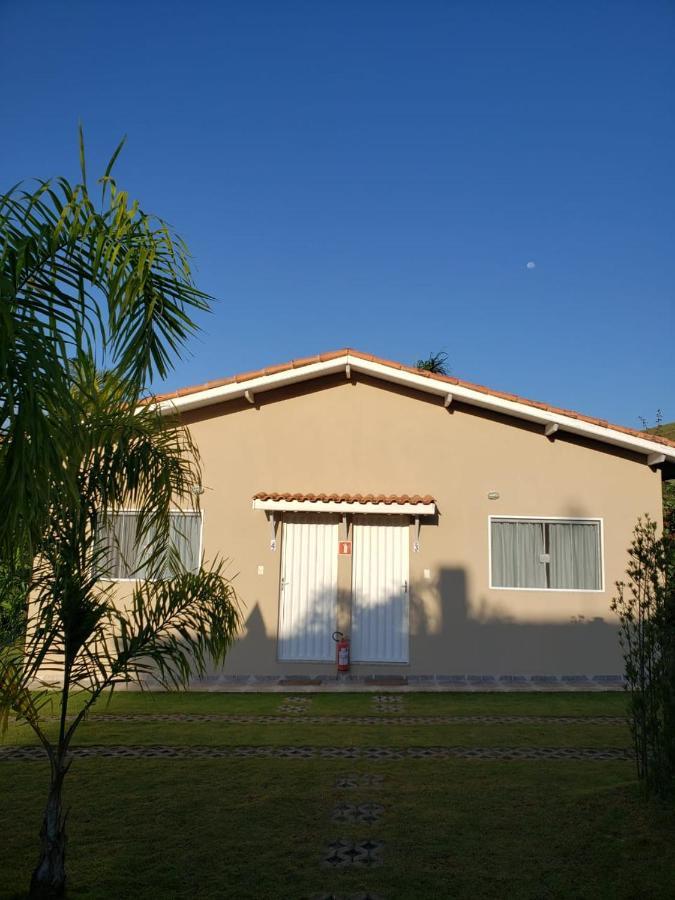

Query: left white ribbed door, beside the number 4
left=278, top=513, right=338, bottom=662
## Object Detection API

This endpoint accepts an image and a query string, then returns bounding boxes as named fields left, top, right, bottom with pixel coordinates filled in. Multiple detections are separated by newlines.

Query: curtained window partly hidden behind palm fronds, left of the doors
left=98, top=512, right=202, bottom=580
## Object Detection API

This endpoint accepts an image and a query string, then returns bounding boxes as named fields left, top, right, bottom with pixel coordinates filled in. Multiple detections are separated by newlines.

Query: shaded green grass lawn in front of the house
left=0, top=694, right=675, bottom=900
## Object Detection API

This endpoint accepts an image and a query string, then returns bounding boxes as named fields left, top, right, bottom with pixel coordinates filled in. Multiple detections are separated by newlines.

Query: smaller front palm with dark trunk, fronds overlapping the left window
left=0, top=356, right=239, bottom=897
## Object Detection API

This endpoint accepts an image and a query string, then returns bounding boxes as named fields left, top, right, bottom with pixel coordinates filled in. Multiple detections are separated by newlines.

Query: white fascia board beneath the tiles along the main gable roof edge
left=152, top=354, right=675, bottom=462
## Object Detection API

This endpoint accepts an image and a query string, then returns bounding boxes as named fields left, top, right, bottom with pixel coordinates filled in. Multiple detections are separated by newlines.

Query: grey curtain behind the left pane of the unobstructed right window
left=492, top=521, right=546, bottom=588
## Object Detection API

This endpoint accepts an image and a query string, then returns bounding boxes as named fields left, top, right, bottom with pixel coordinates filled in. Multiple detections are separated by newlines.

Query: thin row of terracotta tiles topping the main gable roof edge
left=148, top=348, right=675, bottom=447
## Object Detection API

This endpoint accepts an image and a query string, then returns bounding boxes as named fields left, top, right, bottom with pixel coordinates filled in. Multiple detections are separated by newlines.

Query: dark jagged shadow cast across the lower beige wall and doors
left=220, top=568, right=623, bottom=675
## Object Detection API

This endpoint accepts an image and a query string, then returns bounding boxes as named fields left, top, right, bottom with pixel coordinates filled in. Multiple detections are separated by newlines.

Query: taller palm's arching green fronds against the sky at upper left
left=0, top=130, right=211, bottom=561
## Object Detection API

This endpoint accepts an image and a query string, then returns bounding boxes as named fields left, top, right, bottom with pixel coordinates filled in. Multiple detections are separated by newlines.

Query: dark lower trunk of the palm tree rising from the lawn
left=29, top=761, right=66, bottom=900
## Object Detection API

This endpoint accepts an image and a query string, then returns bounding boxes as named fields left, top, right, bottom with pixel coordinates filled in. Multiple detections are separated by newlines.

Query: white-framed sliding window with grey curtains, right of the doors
left=490, top=519, right=602, bottom=591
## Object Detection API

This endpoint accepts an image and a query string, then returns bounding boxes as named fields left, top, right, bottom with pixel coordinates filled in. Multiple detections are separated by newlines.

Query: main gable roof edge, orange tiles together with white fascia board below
left=153, top=348, right=675, bottom=465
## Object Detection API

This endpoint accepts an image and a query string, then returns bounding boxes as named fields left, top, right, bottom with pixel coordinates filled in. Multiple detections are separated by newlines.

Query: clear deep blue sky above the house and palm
left=0, top=0, right=675, bottom=427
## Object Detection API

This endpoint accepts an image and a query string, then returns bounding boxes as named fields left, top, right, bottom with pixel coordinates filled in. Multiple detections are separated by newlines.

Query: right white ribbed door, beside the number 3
left=351, top=516, right=410, bottom=663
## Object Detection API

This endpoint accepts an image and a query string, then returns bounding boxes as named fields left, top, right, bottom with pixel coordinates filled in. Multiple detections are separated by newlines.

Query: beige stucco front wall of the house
left=111, top=377, right=661, bottom=675
